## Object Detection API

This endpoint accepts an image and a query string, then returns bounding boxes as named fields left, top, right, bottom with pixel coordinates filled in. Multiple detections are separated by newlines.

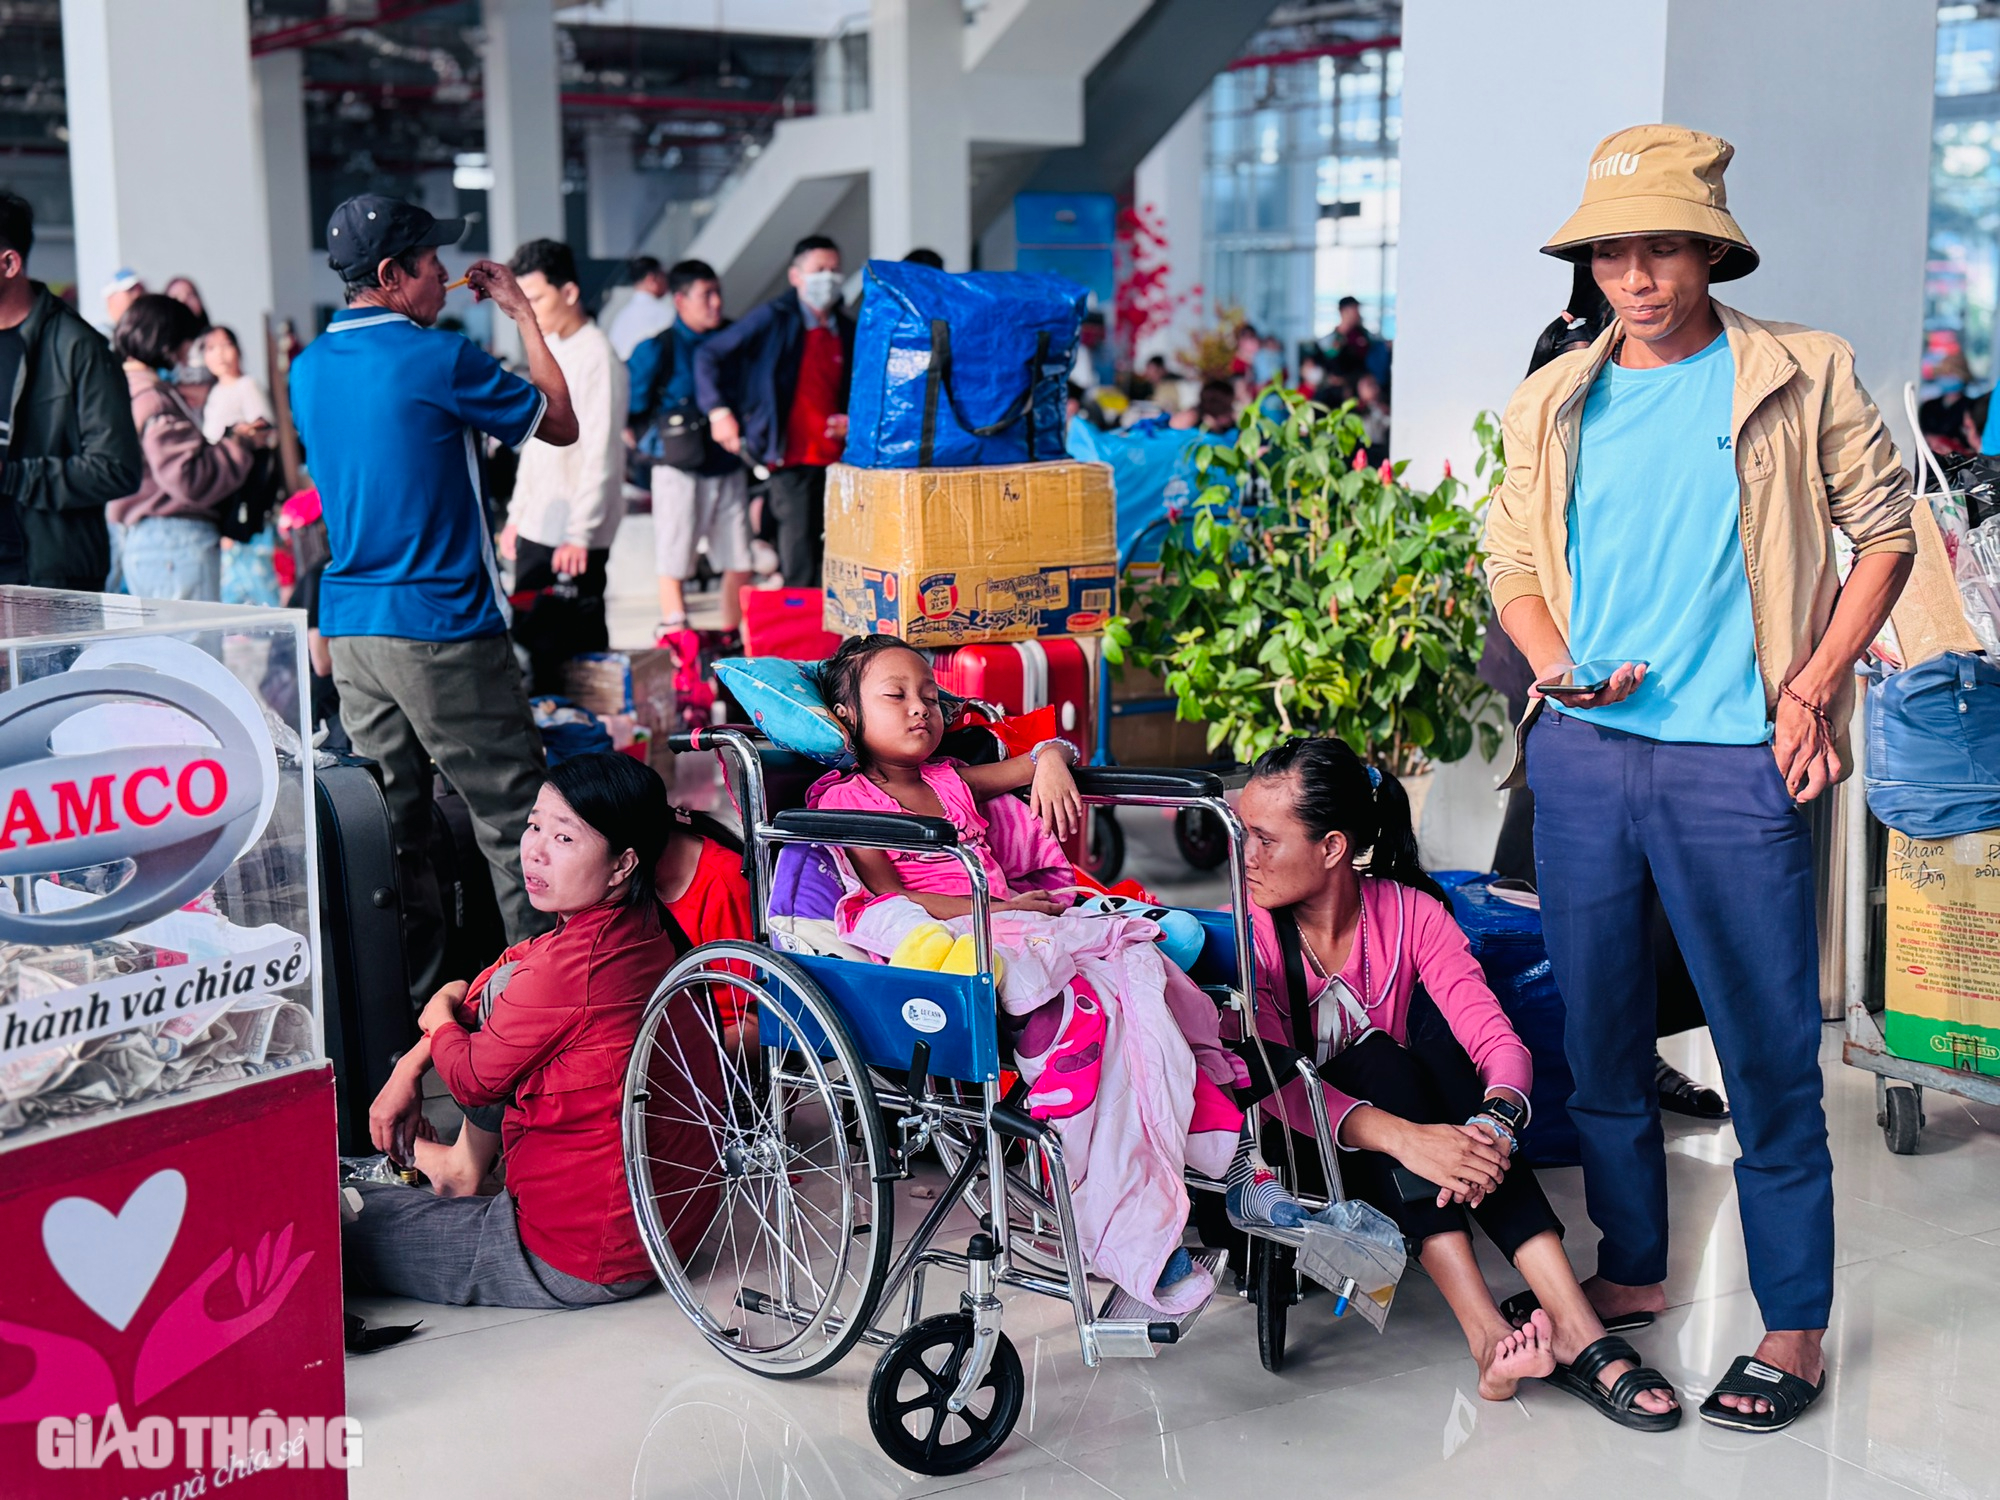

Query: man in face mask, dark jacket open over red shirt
left=694, top=234, right=854, bottom=588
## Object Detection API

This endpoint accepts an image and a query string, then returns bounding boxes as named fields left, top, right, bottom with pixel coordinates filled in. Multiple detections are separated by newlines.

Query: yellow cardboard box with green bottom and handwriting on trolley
left=1882, top=828, right=2000, bottom=1076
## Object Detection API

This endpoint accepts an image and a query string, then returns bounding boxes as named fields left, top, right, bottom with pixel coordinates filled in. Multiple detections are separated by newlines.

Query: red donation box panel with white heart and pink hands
left=0, top=1066, right=348, bottom=1500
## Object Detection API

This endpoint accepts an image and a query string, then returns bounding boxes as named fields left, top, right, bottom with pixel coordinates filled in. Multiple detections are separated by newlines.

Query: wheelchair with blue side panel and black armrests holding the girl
left=622, top=728, right=1352, bottom=1474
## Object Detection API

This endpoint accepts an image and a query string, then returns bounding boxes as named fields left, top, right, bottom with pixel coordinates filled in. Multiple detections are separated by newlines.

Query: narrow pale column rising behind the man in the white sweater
left=484, top=0, right=564, bottom=260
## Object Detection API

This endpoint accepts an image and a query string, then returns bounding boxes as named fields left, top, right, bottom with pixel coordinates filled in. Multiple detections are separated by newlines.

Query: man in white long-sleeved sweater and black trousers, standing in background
left=500, top=240, right=626, bottom=692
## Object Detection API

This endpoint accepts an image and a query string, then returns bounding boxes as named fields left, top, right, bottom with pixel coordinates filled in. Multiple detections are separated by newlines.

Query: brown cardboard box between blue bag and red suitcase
left=826, top=462, right=1118, bottom=646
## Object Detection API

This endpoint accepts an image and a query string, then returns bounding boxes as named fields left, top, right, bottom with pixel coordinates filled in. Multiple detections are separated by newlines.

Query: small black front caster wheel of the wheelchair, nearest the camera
left=868, top=1312, right=1028, bottom=1474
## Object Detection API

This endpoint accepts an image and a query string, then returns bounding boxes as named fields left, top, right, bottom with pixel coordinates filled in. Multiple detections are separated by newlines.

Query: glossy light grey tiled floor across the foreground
left=348, top=818, right=2000, bottom=1500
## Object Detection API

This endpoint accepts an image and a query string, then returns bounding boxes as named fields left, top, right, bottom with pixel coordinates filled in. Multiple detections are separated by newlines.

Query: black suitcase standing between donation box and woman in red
left=312, top=754, right=416, bottom=1156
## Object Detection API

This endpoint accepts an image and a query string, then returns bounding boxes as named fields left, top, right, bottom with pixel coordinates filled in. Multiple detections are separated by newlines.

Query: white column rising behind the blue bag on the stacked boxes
left=868, top=0, right=972, bottom=270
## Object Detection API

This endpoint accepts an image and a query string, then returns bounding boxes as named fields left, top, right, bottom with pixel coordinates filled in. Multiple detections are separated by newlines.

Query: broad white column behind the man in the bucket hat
left=1396, top=0, right=1936, bottom=484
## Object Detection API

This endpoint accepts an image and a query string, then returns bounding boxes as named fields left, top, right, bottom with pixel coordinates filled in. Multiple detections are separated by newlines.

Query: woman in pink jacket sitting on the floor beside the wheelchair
left=1240, top=740, right=1680, bottom=1432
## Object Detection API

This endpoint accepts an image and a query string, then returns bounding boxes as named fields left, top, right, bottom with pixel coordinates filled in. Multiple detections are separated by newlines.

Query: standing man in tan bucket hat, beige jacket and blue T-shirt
left=1486, top=124, right=1916, bottom=1432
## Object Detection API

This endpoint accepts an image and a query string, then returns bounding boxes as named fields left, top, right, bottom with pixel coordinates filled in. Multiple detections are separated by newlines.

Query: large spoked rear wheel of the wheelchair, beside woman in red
left=624, top=942, right=896, bottom=1380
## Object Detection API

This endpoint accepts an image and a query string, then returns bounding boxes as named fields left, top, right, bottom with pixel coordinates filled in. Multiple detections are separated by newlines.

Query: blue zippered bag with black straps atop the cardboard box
left=842, top=260, right=1088, bottom=468
